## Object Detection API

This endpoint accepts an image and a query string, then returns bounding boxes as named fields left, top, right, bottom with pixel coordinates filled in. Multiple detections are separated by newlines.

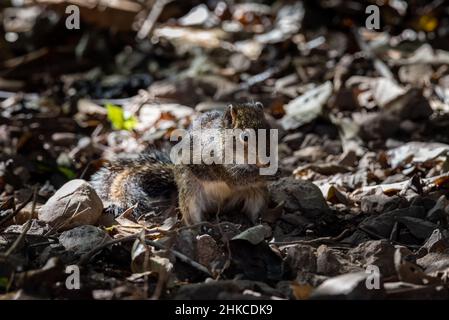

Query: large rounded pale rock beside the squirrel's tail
left=38, top=179, right=103, bottom=230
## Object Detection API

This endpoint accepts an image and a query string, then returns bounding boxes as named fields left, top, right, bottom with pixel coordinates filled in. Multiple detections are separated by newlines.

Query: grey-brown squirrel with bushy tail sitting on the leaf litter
left=91, top=102, right=270, bottom=225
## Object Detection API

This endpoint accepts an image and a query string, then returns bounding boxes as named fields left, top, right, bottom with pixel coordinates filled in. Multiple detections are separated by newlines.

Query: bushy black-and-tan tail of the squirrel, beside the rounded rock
left=91, top=151, right=176, bottom=216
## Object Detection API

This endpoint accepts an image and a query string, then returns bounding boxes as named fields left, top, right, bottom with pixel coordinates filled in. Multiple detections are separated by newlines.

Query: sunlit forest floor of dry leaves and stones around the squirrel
left=0, top=0, right=449, bottom=299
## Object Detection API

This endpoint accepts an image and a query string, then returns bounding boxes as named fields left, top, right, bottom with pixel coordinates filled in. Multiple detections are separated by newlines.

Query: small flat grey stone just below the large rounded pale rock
left=59, top=225, right=111, bottom=255
